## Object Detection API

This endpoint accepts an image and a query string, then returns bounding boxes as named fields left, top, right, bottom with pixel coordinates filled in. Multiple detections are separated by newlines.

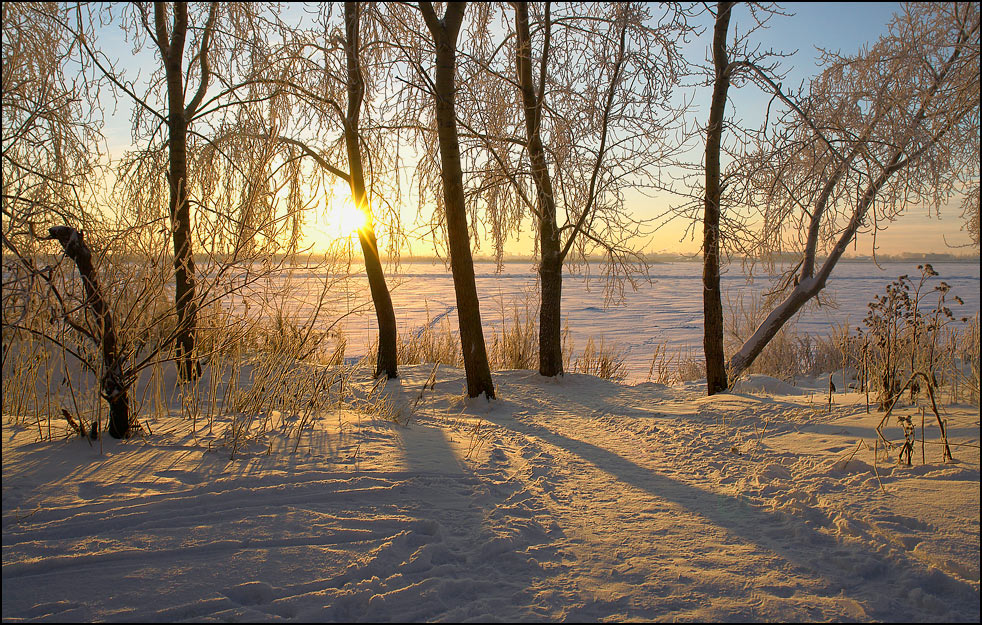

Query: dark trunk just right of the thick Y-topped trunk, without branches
left=515, top=2, right=564, bottom=377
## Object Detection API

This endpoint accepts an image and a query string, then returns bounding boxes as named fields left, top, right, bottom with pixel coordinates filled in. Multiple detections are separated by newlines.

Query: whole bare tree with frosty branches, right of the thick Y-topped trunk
left=460, top=2, right=688, bottom=376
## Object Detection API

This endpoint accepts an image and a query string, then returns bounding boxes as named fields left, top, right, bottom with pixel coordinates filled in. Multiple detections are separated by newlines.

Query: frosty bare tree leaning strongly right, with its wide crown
left=729, top=3, right=979, bottom=376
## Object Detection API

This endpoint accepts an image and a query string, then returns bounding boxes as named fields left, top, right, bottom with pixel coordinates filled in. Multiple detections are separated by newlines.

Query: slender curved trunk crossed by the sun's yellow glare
left=344, top=2, right=398, bottom=378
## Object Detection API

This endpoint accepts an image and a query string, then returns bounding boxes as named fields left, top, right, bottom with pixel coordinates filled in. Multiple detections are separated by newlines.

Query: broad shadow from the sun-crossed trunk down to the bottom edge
left=322, top=378, right=545, bottom=621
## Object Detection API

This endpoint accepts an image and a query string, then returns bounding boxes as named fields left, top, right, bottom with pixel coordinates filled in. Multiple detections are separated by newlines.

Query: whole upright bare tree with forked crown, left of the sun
left=65, top=2, right=298, bottom=380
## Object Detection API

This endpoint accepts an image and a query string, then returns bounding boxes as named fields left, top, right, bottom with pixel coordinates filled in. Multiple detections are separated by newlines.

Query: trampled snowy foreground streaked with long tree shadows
left=2, top=365, right=980, bottom=622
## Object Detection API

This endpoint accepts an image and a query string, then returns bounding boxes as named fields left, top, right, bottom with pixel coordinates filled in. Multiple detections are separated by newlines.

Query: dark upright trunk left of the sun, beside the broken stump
left=154, top=2, right=201, bottom=380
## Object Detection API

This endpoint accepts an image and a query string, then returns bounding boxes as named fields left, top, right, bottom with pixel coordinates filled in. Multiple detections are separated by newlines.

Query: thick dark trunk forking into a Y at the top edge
left=420, top=2, right=494, bottom=399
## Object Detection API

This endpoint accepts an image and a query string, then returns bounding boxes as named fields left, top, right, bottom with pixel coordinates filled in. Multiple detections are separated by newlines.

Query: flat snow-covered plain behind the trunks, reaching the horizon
left=320, top=261, right=979, bottom=382
